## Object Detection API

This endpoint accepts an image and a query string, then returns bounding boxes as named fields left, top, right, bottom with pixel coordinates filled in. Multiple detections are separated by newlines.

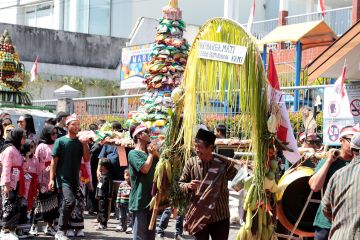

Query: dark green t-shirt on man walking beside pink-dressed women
left=52, top=136, right=83, bottom=188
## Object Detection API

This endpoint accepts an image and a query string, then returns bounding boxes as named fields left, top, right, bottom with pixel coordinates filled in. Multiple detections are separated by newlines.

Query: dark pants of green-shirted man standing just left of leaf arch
left=133, top=209, right=155, bottom=240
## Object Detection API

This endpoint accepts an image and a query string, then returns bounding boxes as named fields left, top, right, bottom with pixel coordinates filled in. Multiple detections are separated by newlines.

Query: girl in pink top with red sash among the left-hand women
left=16, top=139, right=39, bottom=238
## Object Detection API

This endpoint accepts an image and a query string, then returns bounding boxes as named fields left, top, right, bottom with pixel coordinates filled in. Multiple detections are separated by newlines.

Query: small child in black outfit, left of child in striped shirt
left=95, top=159, right=113, bottom=230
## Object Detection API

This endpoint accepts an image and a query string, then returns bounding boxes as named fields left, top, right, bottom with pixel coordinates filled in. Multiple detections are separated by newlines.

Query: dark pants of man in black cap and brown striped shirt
left=194, top=218, right=230, bottom=240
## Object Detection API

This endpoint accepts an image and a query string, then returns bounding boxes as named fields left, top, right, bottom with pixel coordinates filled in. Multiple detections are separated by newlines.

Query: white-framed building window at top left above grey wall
left=25, top=5, right=54, bottom=29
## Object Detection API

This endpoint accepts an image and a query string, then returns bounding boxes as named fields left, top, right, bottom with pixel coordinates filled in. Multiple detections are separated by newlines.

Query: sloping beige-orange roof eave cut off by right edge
left=308, top=21, right=360, bottom=83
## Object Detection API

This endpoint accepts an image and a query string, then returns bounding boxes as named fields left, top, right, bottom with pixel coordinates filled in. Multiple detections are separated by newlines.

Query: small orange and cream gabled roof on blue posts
left=259, top=20, right=337, bottom=49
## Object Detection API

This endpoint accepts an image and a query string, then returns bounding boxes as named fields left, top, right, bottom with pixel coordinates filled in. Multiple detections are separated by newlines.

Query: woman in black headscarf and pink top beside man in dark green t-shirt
left=30, top=125, right=58, bottom=236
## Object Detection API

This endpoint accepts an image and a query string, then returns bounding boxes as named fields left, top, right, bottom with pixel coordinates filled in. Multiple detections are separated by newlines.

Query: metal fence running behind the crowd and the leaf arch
left=33, top=85, right=326, bottom=138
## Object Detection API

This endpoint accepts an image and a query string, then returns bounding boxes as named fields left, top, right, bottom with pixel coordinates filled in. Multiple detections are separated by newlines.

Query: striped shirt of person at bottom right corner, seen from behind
left=321, top=159, right=360, bottom=240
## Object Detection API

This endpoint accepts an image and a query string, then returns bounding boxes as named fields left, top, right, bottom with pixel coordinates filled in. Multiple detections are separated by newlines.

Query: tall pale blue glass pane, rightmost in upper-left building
left=89, top=0, right=111, bottom=35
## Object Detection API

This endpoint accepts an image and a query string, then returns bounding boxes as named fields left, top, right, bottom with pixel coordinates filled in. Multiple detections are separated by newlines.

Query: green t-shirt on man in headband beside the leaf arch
left=128, top=150, right=156, bottom=211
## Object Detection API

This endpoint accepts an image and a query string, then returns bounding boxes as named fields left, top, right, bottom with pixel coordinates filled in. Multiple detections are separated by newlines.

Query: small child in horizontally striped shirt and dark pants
left=116, top=168, right=132, bottom=233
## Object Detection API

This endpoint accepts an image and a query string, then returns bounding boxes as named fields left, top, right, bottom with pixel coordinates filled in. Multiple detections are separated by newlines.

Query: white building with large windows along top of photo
left=0, top=0, right=352, bottom=37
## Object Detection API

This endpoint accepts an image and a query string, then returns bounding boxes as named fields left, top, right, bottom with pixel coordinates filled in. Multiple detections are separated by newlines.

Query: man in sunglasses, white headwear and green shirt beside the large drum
left=309, top=126, right=358, bottom=240
